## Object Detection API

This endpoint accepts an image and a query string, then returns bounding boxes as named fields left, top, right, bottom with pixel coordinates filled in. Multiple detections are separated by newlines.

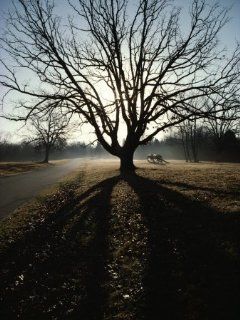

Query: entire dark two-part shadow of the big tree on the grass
left=0, top=175, right=240, bottom=320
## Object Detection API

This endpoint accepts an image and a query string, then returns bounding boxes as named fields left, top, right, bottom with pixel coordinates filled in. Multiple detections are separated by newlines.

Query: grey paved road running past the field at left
left=0, top=158, right=84, bottom=218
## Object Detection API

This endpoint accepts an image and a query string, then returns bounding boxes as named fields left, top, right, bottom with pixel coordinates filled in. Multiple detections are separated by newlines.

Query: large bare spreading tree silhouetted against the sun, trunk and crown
left=0, top=0, right=239, bottom=171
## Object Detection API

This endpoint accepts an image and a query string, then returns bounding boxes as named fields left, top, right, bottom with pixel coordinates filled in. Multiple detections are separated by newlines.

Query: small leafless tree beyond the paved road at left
left=28, top=111, right=70, bottom=163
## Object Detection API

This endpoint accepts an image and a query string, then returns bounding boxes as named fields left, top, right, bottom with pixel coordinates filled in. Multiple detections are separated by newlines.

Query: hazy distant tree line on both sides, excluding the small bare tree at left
left=0, top=123, right=240, bottom=162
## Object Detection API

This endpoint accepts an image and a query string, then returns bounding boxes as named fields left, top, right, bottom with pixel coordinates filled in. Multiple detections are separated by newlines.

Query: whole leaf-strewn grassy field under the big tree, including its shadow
left=0, top=161, right=240, bottom=320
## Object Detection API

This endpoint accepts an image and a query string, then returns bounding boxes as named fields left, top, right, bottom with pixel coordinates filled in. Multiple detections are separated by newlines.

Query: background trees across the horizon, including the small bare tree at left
left=0, top=105, right=240, bottom=162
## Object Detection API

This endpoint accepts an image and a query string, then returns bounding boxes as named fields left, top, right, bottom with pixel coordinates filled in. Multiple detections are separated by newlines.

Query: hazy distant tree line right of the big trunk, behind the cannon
left=135, top=125, right=240, bottom=162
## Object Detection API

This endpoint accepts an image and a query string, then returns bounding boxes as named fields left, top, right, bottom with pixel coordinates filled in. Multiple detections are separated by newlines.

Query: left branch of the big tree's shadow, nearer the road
left=0, top=177, right=119, bottom=320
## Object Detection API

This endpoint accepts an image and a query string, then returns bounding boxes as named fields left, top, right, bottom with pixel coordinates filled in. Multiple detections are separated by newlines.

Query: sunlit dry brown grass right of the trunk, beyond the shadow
left=137, top=160, right=240, bottom=213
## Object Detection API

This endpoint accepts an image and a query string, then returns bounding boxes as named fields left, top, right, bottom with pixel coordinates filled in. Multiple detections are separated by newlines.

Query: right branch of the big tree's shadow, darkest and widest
left=124, top=175, right=240, bottom=320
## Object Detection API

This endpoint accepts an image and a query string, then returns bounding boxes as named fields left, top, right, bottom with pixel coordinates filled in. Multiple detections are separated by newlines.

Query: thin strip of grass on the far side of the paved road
left=0, top=160, right=64, bottom=177
